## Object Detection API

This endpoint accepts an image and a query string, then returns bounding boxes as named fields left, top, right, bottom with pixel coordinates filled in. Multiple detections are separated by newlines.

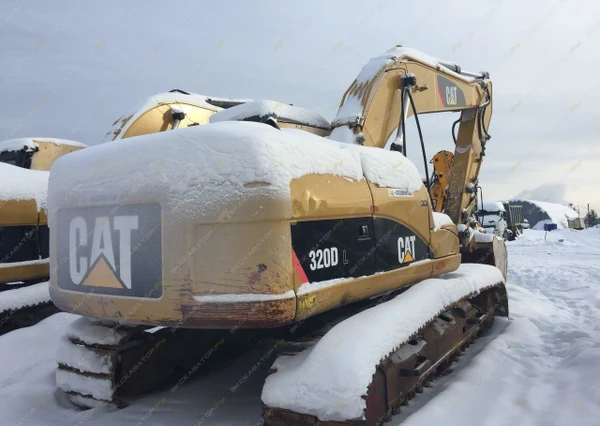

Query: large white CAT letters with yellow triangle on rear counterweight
left=69, top=216, right=139, bottom=289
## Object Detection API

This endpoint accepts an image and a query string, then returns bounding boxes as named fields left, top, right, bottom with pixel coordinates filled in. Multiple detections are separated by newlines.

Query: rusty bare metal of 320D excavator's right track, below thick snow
left=262, top=283, right=508, bottom=426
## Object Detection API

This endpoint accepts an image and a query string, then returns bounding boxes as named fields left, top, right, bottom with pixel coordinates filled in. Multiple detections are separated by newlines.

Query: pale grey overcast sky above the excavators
left=0, top=0, right=600, bottom=213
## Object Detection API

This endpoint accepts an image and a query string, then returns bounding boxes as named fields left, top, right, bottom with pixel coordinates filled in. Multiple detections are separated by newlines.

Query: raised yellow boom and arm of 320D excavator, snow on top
left=331, top=46, right=492, bottom=224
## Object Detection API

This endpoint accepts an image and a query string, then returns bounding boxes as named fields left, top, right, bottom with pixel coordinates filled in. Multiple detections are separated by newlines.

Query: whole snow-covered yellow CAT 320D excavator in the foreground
left=49, top=46, right=508, bottom=425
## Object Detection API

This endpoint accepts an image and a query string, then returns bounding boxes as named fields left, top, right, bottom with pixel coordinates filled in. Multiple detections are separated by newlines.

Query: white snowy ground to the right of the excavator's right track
left=391, top=229, right=600, bottom=426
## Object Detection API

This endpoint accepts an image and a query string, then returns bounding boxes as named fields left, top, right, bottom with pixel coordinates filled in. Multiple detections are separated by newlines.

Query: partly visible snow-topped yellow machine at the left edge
left=0, top=138, right=85, bottom=334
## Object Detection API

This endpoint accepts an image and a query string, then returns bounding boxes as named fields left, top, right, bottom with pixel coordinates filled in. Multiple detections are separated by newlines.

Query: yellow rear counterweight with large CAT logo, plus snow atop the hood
left=48, top=122, right=422, bottom=327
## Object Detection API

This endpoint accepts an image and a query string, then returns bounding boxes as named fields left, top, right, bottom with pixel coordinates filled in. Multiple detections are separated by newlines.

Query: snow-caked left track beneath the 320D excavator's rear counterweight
left=56, top=318, right=260, bottom=408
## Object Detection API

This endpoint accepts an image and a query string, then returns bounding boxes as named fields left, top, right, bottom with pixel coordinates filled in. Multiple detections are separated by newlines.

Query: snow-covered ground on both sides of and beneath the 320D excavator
left=0, top=228, right=600, bottom=426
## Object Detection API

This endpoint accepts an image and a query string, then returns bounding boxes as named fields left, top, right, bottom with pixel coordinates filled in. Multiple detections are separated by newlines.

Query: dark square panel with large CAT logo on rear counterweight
left=56, top=204, right=162, bottom=297
